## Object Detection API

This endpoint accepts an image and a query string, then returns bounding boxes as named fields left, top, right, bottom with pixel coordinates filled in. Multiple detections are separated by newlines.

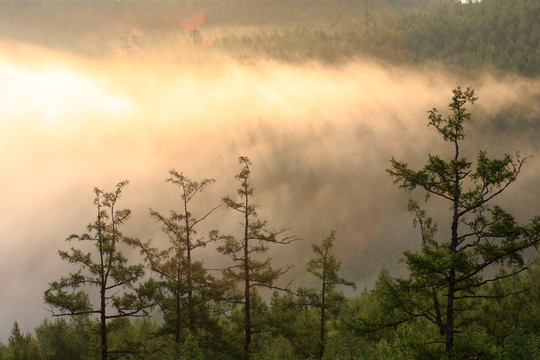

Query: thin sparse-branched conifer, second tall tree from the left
left=127, top=169, right=222, bottom=354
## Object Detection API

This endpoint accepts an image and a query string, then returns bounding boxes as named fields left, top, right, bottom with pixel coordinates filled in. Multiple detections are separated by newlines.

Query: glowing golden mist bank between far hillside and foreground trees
left=0, top=43, right=540, bottom=342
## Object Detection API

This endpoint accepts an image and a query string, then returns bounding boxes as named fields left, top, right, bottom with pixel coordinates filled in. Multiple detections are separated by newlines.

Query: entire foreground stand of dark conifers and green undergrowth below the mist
left=0, top=87, right=540, bottom=360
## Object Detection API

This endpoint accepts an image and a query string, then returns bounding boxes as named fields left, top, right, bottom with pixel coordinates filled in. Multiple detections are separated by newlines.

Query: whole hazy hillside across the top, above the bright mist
left=0, top=0, right=540, bottom=77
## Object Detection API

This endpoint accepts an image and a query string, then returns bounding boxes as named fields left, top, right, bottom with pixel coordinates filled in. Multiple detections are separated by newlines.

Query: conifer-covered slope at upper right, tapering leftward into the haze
left=216, top=0, right=540, bottom=77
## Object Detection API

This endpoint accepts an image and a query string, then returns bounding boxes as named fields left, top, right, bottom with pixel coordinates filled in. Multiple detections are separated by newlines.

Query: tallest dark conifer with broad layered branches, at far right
left=388, top=87, right=540, bottom=354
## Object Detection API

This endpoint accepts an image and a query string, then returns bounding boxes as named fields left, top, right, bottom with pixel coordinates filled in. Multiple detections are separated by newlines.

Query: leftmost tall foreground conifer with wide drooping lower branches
left=44, top=181, right=156, bottom=360
